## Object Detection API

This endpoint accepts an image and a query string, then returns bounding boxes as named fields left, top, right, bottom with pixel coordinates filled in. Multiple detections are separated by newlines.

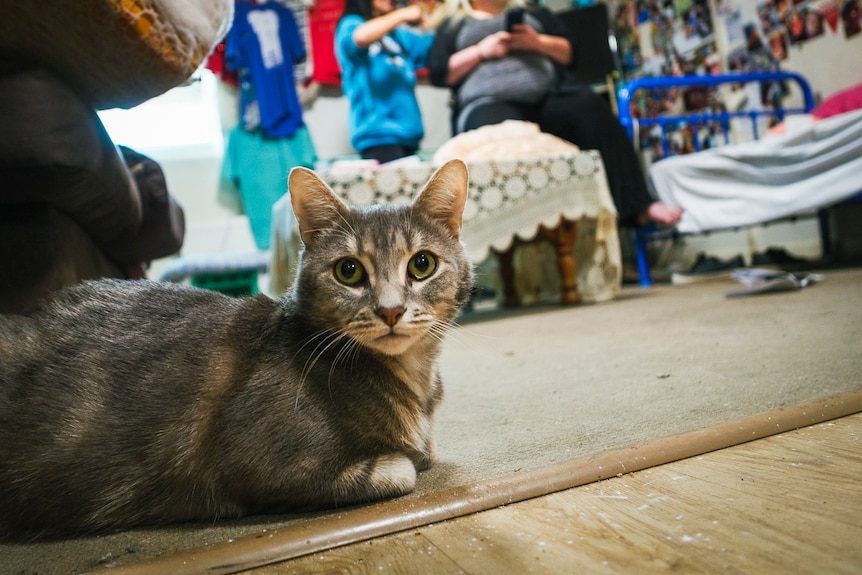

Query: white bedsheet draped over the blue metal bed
left=649, top=110, right=862, bottom=233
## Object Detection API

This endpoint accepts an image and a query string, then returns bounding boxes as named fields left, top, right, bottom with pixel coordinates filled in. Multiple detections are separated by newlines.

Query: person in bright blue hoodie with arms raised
left=335, top=0, right=434, bottom=163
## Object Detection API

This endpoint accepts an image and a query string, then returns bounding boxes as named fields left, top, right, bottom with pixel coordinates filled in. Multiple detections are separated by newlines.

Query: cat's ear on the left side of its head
left=287, top=167, right=347, bottom=245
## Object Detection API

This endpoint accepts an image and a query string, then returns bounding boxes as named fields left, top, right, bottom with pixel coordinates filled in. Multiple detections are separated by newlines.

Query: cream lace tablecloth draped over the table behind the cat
left=271, top=150, right=622, bottom=301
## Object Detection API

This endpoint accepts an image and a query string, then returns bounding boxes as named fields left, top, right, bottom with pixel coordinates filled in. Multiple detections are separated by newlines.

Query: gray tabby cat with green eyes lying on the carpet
left=0, top=160, right=473, bottom=537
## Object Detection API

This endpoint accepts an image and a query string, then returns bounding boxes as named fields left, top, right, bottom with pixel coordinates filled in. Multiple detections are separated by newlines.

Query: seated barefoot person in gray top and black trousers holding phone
left=428, top=0, right=682, bottom=230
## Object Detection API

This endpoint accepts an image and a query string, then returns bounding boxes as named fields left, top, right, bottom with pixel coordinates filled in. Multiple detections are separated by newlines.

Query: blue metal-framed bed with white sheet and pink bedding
left=619, top=72, right=862, bottom=287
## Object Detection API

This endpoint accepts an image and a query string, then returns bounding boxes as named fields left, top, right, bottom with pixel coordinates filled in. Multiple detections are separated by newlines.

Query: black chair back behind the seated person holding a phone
left=557, top=2, right=620, bottom=114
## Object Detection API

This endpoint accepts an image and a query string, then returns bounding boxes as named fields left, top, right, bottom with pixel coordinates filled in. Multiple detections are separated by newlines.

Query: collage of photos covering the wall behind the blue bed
left=608, top=0, right=862, bottom=162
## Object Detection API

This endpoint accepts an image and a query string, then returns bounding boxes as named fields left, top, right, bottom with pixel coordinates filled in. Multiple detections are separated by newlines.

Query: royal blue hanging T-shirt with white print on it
left=225, top=2, right=306, bottom=138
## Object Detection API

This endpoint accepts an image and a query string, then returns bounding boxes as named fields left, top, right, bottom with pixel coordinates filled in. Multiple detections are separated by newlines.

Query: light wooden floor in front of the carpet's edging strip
left=251, top=414, right=862, bottom=575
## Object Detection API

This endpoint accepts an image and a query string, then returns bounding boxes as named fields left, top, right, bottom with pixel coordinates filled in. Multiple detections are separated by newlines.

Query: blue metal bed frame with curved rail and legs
left=617, top=72, right=831, bottom=287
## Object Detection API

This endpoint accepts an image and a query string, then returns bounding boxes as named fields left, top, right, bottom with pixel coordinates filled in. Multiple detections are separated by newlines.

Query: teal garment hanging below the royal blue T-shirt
left=221, top=125, right=317, bottom=250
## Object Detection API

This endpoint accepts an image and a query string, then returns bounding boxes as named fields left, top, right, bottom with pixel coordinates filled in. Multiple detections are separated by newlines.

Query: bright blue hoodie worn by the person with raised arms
left=335, top=14, right=434, bottom=152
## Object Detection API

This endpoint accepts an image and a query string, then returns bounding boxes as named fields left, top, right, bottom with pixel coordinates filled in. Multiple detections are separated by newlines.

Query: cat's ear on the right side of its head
left=413, top=160, right=468, bottom=238
